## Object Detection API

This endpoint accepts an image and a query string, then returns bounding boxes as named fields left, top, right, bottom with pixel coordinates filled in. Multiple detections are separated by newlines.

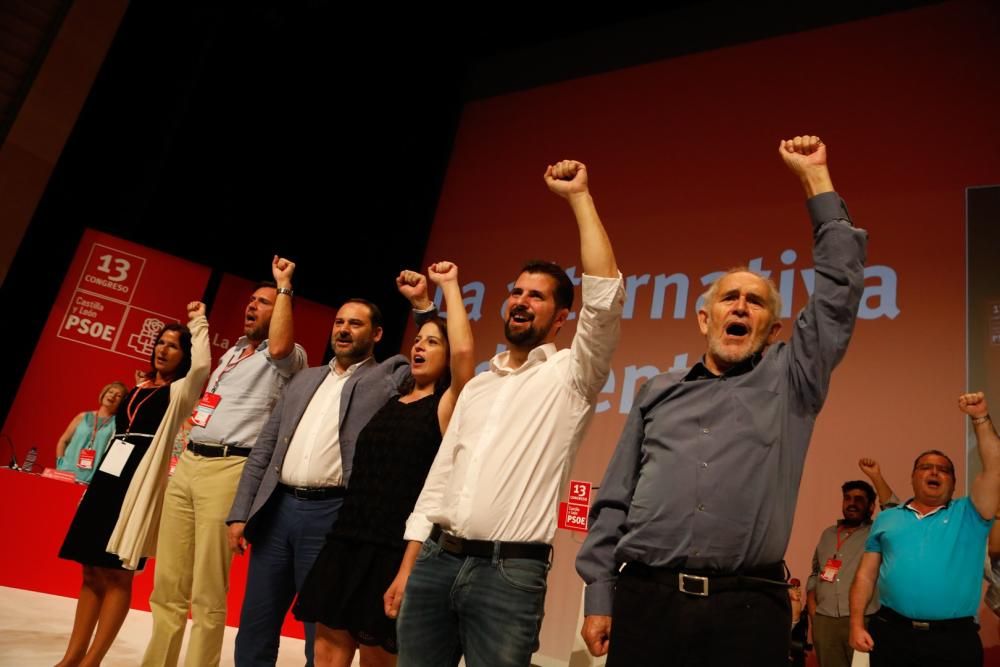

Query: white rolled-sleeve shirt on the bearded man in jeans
left=405, top=274, right=624, bottom=543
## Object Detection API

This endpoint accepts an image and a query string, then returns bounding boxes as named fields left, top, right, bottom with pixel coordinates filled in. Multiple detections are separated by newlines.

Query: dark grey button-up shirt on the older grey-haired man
left=577, top=192, right=867, bottom=615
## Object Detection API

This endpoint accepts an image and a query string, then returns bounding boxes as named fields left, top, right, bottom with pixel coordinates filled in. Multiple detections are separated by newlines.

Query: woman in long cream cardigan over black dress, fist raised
left=58, top=301, right=211, bottom=667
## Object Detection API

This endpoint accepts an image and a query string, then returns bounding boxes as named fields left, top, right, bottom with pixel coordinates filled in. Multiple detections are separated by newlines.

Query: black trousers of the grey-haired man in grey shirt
left=607, top=566, right=792, bottom=667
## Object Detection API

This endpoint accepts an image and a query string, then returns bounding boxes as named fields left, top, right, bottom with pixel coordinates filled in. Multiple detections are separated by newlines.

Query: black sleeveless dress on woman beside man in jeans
left=294, top=396, right=441, bottom=653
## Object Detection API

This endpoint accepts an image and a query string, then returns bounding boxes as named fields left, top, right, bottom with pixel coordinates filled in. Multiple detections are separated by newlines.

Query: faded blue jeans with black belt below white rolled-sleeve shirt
left=396, top=540, right=549, bottom=667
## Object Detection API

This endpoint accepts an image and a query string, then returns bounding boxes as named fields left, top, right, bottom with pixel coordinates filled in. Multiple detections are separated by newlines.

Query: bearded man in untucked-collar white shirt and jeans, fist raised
left=394, top=160, right=624, bottom=667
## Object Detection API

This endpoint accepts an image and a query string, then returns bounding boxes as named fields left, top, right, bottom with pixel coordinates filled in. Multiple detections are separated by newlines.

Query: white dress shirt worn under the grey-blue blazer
left=280, top=359, right=368, bottom=488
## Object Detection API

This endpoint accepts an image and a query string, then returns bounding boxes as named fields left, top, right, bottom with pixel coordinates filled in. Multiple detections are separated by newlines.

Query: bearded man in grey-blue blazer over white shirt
left=226, top=286, right=434, bottom=667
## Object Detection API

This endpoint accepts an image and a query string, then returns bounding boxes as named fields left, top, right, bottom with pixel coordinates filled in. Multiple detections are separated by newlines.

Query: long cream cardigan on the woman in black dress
left=107, top=316, right=212, bottom=570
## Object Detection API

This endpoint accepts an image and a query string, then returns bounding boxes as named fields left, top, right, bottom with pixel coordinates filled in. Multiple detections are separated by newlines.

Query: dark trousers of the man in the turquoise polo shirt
left=868, top=610, right=983, bottom=667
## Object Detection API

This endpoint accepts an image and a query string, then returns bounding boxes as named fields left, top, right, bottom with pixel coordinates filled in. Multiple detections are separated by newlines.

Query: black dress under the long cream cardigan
left=59, top=385, right=170, bottom=570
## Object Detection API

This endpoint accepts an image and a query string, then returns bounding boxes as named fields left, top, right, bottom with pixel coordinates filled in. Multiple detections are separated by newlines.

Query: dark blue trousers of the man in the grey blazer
left=236, top=489, right=344, bottom=667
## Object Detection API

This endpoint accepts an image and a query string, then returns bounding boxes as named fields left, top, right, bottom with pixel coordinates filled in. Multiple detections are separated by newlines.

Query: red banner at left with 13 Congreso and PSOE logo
left=4, top=230, right=210, bottom=470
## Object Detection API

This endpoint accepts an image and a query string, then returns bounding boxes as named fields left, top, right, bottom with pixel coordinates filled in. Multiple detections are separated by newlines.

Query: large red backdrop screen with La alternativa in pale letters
left=406, top=2, right=1000, bottom=660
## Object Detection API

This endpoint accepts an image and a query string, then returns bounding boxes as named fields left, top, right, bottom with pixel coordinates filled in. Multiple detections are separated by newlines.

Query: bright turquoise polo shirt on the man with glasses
left=865, top=496, right=993, bottom=621
